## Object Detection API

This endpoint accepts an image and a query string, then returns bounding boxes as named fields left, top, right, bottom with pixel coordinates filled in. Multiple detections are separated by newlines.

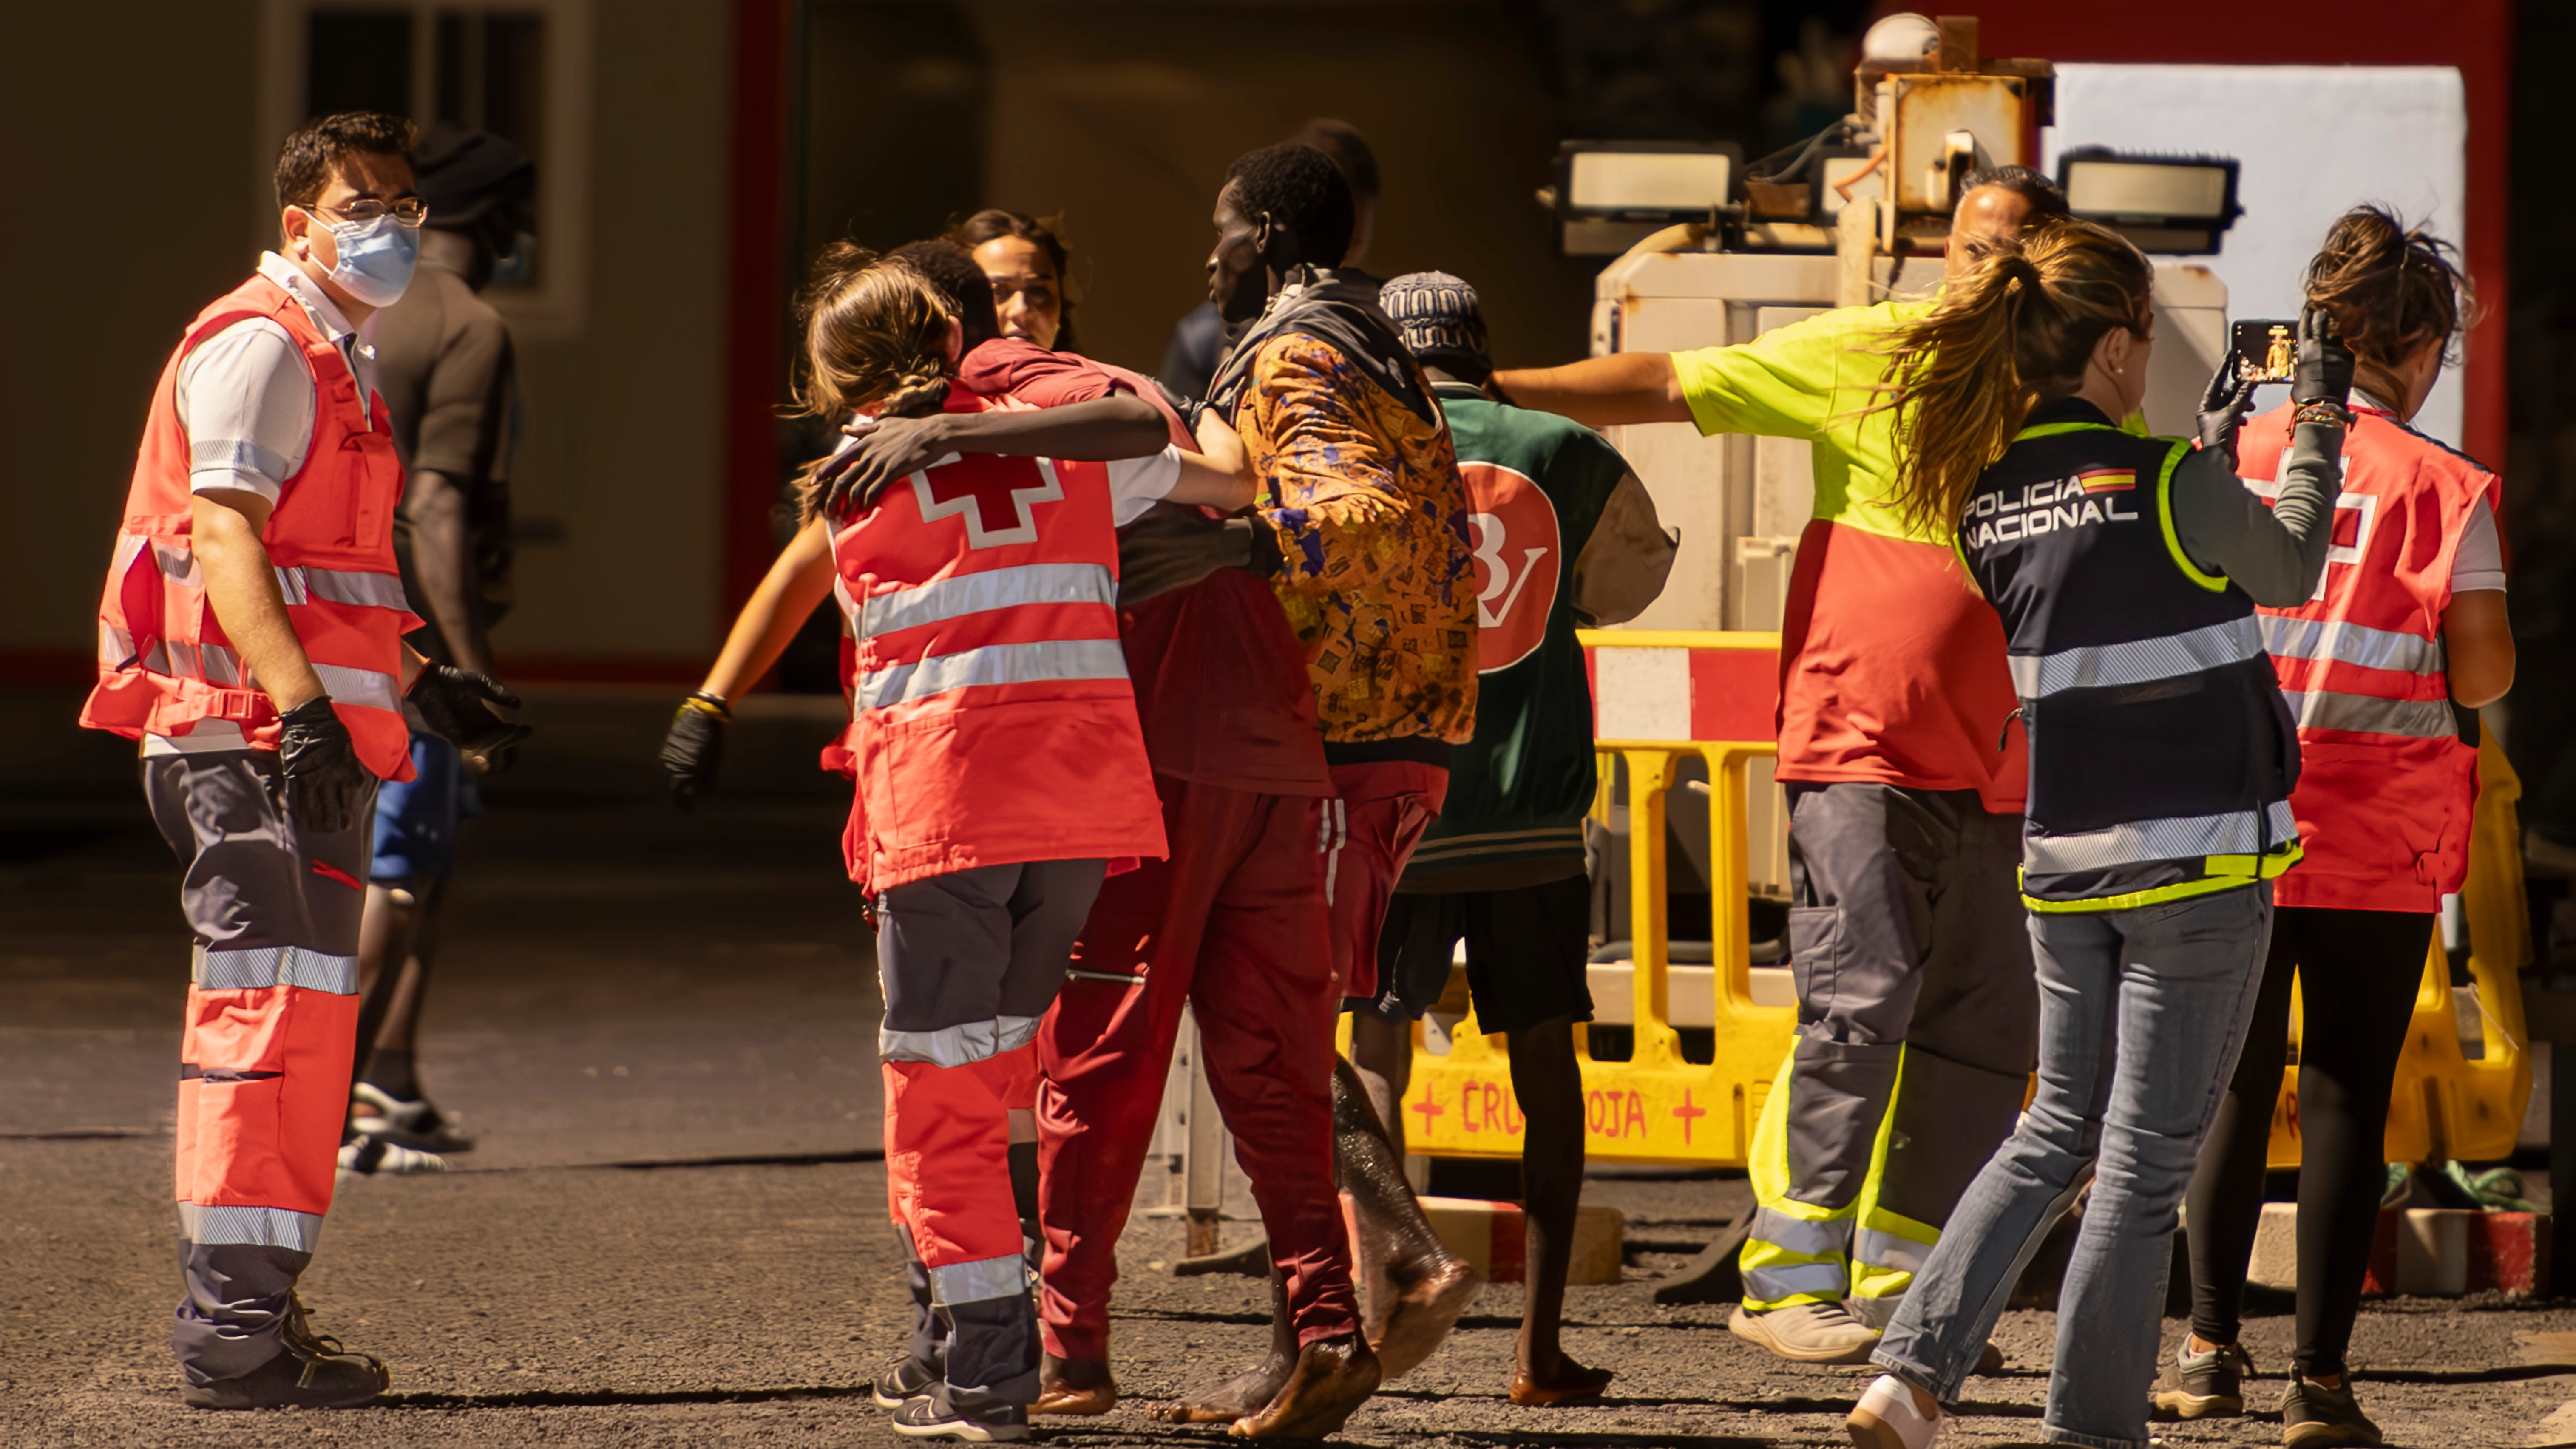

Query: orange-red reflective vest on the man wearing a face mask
left=80, top=275, right=420, bottom=780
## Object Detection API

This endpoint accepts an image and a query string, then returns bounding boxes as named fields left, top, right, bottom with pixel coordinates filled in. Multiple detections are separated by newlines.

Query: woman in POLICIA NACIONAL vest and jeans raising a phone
left=1850, top=221, right=2352, bottom=1449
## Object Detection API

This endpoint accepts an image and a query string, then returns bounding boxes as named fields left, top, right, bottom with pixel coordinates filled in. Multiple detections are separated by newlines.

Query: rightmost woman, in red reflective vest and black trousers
left=2156, top=206, right=2514, bottom=1446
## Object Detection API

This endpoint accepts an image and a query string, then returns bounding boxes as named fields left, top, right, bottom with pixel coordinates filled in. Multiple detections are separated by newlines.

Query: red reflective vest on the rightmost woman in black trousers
left=2236, top=407, right=2501, bottom=911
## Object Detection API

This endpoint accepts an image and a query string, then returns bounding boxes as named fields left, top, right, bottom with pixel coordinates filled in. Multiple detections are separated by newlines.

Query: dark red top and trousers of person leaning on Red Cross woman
left=961, top=340, right=1360, bottom=1413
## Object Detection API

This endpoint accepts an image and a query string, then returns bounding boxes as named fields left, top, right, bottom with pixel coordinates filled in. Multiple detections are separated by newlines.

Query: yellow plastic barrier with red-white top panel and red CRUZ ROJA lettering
left=1404, top=630, right=1796, bottom=1166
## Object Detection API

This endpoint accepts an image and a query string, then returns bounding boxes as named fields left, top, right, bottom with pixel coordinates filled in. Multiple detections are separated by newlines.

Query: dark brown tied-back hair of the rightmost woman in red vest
left=2306, top=206, right=2478, bottom=404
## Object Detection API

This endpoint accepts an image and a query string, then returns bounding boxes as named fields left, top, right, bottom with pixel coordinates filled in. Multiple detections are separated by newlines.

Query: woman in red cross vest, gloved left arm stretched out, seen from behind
left=664, top=247, right=1249, bottom=1441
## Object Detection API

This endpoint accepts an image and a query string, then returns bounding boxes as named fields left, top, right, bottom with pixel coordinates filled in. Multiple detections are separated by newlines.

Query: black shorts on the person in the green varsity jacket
left=1345, top=875, right=1592, bottom=1032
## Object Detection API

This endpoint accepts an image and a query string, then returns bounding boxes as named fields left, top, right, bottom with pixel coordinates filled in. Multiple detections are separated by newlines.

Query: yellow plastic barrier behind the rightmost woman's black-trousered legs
left=2267, top=731, right=2532, bottom=1168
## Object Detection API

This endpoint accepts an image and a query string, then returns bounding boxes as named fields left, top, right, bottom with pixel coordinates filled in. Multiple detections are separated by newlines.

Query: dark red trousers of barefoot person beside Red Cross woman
left=1038, top=777, right=1360, bottom=1359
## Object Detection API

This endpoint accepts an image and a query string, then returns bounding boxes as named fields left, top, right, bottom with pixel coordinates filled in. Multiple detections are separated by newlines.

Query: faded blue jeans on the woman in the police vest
left=1873, top=883, right=2272, bottom=1449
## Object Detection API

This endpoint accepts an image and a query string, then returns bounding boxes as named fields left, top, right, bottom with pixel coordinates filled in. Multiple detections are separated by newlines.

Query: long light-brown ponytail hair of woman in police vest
left=1870, top=221, right=2156, bottom=535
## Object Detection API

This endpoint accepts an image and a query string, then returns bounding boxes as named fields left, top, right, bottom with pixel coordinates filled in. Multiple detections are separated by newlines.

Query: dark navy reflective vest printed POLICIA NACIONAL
left=1958, top=402, right=2301, bottom=911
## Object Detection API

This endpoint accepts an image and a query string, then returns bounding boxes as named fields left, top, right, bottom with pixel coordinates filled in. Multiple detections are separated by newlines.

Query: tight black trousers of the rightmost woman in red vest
left=2187, top=906, right=2434, bottom=1374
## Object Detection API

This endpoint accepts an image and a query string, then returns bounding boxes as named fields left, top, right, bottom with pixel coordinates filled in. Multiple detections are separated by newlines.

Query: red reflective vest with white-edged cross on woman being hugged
left=832, top=383, right=1167, bottom=890
